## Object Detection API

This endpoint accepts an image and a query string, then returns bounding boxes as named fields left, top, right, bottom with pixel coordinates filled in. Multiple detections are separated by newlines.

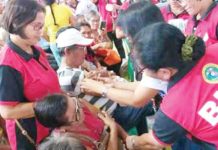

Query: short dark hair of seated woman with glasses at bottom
left=34, top=94, right=68, bottom=128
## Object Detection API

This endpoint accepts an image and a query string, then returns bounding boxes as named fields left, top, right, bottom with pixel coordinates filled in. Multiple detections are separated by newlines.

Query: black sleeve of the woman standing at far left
left=0, top=66, right=25, bottom=105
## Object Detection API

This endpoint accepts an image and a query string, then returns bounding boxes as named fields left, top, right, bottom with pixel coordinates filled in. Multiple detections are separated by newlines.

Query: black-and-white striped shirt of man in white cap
left=57, top=67, right=117, bottom=114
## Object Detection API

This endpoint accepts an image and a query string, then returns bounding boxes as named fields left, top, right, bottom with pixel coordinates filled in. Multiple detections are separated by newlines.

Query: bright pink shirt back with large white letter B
left=161, top=44, right=218, bottom=148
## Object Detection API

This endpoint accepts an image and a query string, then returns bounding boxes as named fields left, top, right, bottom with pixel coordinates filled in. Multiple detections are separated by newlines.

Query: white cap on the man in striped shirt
left=56, top=28, right=93, bottom=48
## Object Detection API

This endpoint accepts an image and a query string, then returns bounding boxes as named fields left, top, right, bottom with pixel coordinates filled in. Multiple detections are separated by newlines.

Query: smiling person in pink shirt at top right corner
left=180, top=0, right=218, bottom=46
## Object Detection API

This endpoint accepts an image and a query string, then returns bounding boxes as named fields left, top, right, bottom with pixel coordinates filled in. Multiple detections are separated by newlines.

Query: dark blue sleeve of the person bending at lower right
left=153, top=109, right=187, bottom=145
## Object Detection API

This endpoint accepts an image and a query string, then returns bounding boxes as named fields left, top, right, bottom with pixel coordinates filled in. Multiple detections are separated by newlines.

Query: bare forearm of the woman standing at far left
left=0, top=103, right=34, bottom=119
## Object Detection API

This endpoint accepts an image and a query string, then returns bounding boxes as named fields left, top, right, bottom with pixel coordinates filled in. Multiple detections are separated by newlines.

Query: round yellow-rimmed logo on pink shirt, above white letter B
left=202, top=64, right=218, bottom=84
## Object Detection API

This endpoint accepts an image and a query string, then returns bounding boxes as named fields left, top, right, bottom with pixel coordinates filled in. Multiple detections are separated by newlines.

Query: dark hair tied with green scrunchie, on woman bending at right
left=133, top=23, right=205, bottom=71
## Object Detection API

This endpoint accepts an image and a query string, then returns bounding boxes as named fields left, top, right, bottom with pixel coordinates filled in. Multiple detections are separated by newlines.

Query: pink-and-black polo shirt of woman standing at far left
left=0, top=41, right=60, bottom=150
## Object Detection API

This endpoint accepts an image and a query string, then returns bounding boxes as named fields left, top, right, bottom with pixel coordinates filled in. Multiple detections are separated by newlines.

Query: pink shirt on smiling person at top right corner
left=185, top=2, right=218, bottom=46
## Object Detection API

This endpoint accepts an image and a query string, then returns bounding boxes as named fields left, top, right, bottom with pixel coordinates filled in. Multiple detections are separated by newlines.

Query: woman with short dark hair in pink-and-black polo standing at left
left=0, top=0, right=60, bottom=150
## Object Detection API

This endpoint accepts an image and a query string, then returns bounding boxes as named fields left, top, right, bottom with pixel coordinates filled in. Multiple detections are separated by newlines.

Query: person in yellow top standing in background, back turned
left=44, top=0, right=75, bottom=66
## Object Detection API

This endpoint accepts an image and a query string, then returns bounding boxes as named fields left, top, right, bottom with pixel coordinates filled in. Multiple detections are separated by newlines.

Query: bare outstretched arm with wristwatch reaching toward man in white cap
left=81, top=79, right=158, bottom=107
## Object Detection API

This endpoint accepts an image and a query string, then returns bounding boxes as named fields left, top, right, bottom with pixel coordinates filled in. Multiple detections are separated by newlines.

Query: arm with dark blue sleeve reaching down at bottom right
left=126, top=109, right=187, bottom=150
